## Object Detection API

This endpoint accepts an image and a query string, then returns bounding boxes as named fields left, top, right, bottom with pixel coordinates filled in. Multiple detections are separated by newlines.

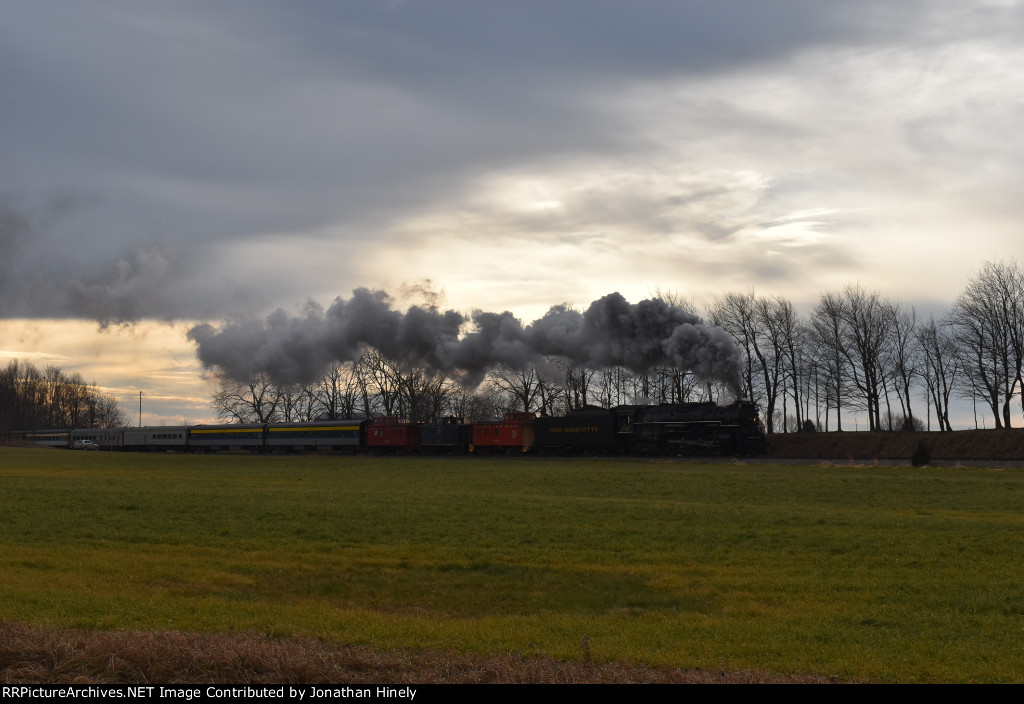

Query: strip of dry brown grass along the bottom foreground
left=0, top=622, right=837, bottom=685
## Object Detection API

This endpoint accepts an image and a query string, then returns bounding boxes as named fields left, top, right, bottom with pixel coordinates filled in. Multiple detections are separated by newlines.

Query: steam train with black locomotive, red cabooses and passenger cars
left=7, top=401, right=765, bottom=456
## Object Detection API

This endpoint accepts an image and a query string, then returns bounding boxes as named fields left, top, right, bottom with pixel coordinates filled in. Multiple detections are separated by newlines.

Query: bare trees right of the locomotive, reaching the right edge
left=709, top=261, right=1024, bottom=432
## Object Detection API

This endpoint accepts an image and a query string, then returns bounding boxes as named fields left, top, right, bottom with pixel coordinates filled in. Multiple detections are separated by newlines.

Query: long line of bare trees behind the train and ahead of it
left=213, top=261, right=1024, bottom=433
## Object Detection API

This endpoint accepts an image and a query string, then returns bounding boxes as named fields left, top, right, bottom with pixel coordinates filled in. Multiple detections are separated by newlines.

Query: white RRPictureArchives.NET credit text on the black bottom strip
left=0, top=685, right=416, bottom=701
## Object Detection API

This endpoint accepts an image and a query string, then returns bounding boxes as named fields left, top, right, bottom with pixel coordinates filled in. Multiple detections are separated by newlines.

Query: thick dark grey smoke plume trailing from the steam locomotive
left=188, top=289, right=741, bottom=391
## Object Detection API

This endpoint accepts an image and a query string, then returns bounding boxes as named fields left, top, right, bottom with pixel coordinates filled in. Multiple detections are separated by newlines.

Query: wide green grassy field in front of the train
left=0, top=448, right=1024, bottom=681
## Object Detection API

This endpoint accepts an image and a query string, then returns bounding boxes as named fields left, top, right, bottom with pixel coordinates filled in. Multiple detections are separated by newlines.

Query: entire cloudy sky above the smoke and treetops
left=0, top=0, right=1024, bottom=423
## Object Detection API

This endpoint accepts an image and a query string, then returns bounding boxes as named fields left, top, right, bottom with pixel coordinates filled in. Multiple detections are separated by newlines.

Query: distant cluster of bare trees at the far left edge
left=0, top=360, right=128, bottom=430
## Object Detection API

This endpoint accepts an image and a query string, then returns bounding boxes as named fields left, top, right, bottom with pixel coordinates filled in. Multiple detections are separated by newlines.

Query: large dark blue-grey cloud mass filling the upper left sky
left=0, top=0, right=897, bottom=321
